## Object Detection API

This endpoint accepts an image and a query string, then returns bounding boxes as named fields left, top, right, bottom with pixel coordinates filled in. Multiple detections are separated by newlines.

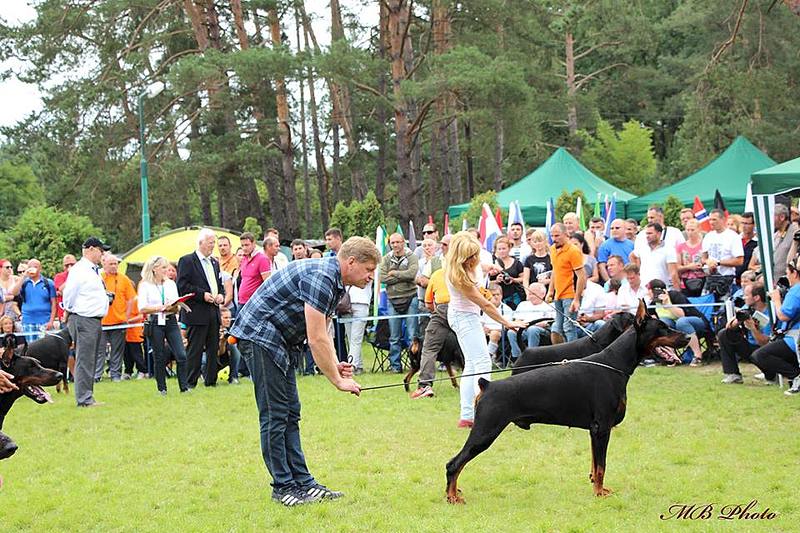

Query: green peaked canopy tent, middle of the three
left=628, top=135, right=775, bottom=219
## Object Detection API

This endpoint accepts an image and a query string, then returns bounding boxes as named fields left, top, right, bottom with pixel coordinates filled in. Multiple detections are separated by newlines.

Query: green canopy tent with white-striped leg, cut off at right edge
left=751, top=157, right=800, bottom=287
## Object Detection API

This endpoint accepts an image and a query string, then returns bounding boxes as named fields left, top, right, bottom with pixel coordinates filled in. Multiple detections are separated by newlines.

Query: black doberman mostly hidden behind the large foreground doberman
left=511, top=313, right=633, bottom=376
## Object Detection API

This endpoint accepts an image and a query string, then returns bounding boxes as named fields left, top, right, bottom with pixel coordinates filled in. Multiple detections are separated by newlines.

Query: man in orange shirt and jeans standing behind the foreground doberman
left=547, top=223, right=586, bottom=344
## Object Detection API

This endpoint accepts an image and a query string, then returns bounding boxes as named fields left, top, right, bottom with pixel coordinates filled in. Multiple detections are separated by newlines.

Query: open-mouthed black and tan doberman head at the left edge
left=0, top=348, right=62, bottom=429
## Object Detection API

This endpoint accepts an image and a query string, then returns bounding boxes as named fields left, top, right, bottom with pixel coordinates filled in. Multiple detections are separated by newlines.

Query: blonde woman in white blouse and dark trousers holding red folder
left=137, top=255, right=189, bottom=396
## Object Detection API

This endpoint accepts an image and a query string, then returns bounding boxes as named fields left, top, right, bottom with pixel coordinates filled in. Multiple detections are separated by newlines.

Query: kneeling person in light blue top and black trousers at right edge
left=751, top=258, right=800, bottom=395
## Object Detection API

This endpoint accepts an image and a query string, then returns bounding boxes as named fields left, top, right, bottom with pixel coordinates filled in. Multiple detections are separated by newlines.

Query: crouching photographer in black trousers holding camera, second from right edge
left=717, top=283, right=772, bottom=384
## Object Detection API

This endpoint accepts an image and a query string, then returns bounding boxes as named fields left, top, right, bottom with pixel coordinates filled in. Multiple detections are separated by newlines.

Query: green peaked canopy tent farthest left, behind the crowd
left=447, top=148, right=633, bottom=226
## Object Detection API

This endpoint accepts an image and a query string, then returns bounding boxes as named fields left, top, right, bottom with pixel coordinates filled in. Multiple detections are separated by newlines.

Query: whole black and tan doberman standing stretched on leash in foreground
left=447, top=302, right=689, bottom=503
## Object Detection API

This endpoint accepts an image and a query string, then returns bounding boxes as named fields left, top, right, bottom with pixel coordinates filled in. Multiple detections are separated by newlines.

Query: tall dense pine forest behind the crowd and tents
left=0, top=0, right=800, bottom=253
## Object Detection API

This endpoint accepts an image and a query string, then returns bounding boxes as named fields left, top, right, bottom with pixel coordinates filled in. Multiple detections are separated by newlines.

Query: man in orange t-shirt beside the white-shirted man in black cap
left=99, top=254, right=136, bottom=382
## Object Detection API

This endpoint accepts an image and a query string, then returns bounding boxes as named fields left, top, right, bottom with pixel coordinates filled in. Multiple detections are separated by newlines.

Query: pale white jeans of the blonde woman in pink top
left=447, top=307, right=492, bottom=420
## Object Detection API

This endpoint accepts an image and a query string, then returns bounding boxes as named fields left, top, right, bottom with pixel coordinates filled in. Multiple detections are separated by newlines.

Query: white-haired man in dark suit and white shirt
left=177, top=228, right=225, bottom=388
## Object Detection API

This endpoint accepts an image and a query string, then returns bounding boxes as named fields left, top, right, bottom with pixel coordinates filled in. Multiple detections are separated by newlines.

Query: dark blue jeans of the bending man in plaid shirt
left=239, top=340, right=315, bottom=492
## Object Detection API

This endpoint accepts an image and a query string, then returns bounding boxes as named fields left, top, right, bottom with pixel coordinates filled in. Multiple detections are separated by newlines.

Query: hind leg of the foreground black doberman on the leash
left=446, top=386, right=510, bottom=503
